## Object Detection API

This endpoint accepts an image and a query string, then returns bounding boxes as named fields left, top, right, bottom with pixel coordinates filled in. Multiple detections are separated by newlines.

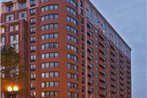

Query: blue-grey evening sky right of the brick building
left=91, top=0, right=147, bottom=98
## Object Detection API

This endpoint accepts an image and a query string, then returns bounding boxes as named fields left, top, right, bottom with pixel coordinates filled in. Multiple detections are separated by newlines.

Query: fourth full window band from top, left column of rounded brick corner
left=41, top=33, right=59, bottom=40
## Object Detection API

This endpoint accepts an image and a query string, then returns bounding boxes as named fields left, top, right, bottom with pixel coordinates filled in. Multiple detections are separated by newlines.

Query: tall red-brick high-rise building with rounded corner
left=0, top=0, right=131, bottom=98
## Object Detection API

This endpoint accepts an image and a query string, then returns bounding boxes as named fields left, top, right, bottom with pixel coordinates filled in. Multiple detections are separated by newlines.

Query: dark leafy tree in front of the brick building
left=0, top=47, right=24, bottom=89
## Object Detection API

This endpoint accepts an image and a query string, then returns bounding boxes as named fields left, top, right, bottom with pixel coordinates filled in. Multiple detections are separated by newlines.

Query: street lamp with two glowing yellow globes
left=7, top=86, right=19, bottom=98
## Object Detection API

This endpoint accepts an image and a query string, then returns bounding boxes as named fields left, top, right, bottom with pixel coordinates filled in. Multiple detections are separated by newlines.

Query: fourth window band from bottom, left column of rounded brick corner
left=41, top=62, right=59, bottom=69
